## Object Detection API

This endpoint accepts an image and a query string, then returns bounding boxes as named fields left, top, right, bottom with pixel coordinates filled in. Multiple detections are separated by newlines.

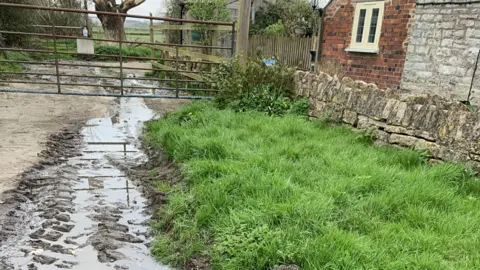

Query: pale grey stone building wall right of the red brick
left=401, top=0, right=480, bottom=104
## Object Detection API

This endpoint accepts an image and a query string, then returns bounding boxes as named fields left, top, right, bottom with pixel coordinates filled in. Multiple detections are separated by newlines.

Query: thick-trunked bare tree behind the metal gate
left=93, top=0, right=145, bottom=40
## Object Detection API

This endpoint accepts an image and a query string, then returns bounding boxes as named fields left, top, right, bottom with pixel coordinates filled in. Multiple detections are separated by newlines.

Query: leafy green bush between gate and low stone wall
left=204, top=58, right=308, bottom=115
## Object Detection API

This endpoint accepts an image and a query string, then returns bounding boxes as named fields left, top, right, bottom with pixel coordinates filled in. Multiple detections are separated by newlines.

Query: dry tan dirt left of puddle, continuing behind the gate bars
left=0, top=62, right=157, bottom=195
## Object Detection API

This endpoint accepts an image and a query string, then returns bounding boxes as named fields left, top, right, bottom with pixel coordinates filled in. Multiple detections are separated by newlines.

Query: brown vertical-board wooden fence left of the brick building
left=248, top=35, right=316, bottom=70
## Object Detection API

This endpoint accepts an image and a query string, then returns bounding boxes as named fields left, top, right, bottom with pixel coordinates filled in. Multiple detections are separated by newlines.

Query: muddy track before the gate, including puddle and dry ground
left=0, top=60, right=190, bottom=270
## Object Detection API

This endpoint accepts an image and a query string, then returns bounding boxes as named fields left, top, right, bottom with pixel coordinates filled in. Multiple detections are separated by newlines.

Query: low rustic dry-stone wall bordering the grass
left=295, top=71, right=480, bottom=169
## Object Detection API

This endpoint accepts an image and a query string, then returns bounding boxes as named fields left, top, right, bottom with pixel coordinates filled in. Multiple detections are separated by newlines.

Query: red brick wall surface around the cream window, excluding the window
left=320, top=0, right=415, bottom=89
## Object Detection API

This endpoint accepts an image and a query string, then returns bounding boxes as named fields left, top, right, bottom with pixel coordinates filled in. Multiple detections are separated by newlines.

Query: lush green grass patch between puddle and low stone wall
left=145, top=103, right=480, bottom=269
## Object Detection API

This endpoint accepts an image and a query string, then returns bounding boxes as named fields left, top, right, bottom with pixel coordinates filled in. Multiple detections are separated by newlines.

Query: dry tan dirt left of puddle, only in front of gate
left=0, top=93, right=112, bottom=194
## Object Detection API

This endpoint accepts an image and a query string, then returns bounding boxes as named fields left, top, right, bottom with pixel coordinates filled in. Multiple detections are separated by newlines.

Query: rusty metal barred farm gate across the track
left=0, top=3, right=235, bottom=99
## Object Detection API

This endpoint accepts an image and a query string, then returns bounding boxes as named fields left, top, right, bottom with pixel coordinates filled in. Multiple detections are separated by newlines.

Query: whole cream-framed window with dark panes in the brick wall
left=346, top=1, right=384, bottom=53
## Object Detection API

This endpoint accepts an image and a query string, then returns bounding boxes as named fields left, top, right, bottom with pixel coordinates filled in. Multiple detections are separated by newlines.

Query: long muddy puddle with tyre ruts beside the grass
left=0, top=98, right=168, bottom=270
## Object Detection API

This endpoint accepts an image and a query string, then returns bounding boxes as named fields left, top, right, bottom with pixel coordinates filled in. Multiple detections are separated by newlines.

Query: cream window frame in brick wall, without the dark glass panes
left=345, top=1, right=385, bottom=53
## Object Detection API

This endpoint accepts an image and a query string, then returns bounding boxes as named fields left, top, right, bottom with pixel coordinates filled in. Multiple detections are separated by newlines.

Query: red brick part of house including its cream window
left=320, top=0, right=415, bottom=89
